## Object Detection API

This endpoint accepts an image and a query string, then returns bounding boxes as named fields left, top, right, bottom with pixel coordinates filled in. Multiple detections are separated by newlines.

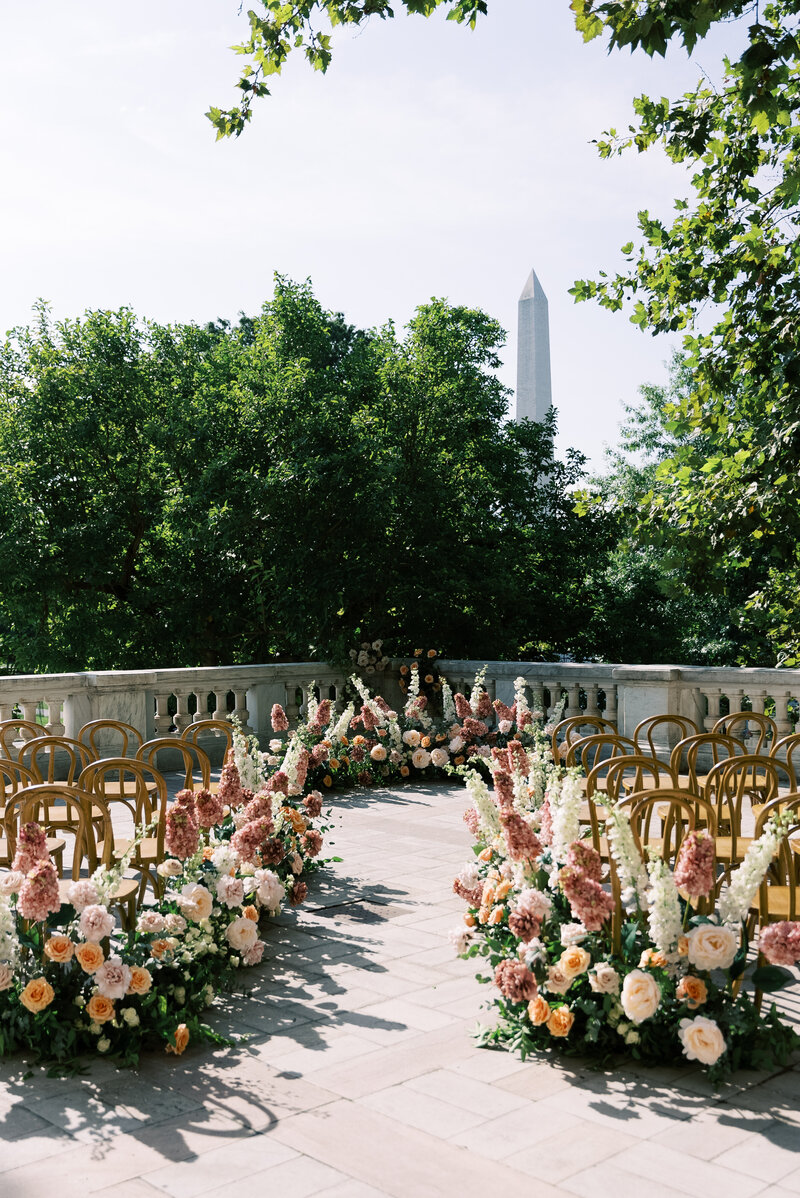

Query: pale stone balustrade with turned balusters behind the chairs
left=0, top=660, right=800, bottom=748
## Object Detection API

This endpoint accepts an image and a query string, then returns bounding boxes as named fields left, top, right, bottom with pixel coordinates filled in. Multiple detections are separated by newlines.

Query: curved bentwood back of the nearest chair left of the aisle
left=4, top=782, right=111, bottom=881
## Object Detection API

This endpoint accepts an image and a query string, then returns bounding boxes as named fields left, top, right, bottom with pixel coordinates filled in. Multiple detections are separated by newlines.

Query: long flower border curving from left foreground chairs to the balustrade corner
left=0, top=662, right=534, bottom=1065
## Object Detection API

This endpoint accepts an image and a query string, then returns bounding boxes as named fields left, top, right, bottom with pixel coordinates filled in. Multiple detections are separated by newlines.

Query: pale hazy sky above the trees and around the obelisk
left=0, top=0, right=735, bottom=468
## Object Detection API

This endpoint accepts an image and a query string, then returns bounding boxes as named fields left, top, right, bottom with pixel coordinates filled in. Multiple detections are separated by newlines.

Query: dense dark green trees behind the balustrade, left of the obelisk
left=0, top=279, right=608, bottom=671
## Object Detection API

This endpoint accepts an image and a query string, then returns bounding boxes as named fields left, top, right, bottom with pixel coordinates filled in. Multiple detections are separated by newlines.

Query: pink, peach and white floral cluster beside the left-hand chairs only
left=0, top=730, right=326, bottom=1065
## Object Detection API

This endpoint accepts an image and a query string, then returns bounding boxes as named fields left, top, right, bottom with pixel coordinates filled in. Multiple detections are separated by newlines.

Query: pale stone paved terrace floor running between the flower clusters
left=0, top=786, right=800, bottom=1198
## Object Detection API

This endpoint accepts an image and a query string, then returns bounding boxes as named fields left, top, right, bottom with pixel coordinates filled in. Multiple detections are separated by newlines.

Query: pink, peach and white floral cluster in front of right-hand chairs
left=453, top=736, right=800, bottom=1081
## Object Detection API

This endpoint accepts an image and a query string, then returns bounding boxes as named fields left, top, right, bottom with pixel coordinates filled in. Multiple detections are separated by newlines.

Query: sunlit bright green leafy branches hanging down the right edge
left=574, top=0, right=800, bottom=665
